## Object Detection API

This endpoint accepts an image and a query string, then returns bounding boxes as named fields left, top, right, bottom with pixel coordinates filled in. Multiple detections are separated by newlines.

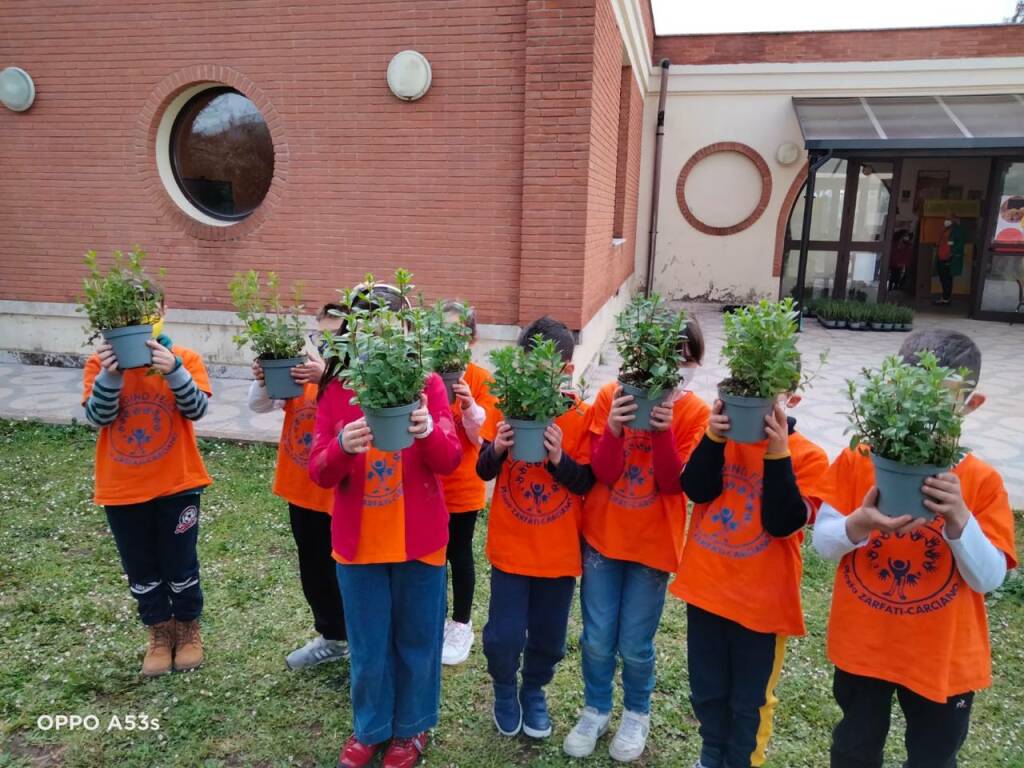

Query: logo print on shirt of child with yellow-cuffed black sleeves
left=691, top=464, right=771, bottom=559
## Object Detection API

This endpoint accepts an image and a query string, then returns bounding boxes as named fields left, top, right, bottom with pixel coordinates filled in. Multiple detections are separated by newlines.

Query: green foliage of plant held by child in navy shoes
left=490, top=335, right=570, bottom=422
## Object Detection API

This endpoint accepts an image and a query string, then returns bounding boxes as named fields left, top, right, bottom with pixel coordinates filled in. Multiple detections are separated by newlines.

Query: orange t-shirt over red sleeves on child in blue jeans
left=583, top=382, right=711, bottom=573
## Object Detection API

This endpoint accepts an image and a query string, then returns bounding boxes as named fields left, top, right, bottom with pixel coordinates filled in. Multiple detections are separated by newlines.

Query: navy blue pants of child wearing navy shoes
left=483, top=567, right=575, bottom=688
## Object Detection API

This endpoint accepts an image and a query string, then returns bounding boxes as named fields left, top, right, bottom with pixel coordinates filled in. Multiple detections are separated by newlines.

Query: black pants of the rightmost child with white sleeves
left=830, top=669, right=974, bottom=768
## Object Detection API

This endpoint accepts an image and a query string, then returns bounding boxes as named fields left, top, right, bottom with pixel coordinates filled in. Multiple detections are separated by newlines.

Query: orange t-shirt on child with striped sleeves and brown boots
left=82, top=345, right=212, bottom=506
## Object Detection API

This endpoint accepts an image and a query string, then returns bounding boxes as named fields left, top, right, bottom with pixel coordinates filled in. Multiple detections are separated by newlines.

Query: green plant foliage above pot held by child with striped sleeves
left=77, top=246, right=164, bottom=342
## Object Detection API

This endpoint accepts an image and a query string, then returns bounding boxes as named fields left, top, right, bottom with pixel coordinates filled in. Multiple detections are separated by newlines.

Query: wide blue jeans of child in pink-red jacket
left=337, top=561, right=447, bottom=744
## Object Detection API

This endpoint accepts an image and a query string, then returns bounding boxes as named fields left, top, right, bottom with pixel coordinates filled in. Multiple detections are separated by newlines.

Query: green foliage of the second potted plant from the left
left=228, top=269, right=306, bottom=360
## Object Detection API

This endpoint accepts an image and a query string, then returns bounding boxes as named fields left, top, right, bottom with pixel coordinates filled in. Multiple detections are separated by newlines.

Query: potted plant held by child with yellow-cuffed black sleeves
left=718, top=298, right=825, bottom=442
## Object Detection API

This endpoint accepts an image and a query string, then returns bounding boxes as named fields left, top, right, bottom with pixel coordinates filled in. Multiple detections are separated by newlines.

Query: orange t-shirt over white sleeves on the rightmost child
left=816, top=449, right=1017, bottom=702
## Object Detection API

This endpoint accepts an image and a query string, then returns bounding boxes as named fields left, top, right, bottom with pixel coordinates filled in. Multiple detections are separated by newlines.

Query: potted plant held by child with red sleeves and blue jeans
left=614, top=294, right=688, bottom=429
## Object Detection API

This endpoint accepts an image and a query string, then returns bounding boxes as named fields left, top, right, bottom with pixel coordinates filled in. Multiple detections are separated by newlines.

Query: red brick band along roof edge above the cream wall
left=653, top=25, right=1024, bottom=65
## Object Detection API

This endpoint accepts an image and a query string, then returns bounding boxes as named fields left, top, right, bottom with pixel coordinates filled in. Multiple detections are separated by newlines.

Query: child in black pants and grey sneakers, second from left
left=249, top=303, right=348, bottom=670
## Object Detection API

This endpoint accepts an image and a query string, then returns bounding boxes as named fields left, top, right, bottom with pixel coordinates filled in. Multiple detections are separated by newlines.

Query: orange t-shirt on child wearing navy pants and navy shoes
left=487, top=402, right=590, bottom=579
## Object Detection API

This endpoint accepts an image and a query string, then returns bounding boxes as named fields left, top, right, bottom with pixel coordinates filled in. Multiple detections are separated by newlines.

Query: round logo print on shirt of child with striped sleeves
left=110, top=392, right=177, bottom=466
